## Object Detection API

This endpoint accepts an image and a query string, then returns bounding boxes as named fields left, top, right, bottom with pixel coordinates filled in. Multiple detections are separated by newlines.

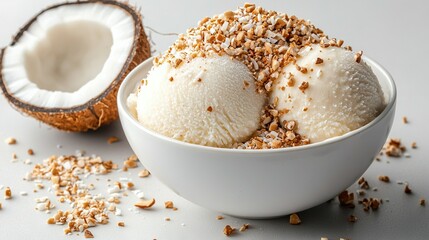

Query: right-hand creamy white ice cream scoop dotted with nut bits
left=270, top=45, right=385, bottom=142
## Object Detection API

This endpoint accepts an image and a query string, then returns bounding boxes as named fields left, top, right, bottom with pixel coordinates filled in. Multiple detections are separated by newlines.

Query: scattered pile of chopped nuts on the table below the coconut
left=25, top=156, right=113, bottom=234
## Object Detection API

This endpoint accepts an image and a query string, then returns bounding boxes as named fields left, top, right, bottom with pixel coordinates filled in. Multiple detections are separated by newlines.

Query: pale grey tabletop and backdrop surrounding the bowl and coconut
left=0, top=0, right=429, bottom=240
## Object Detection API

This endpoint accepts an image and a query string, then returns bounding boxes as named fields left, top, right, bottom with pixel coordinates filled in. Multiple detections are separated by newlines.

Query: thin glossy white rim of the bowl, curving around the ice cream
left=117, top=56, right=397, bottom=154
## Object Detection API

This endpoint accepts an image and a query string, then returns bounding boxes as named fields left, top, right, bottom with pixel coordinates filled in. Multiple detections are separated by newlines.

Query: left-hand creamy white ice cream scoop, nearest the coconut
left=128, top=55, right=266, bottom=147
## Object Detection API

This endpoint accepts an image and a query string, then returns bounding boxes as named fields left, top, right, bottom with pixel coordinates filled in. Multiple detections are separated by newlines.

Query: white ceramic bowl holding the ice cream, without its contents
left=118, top=55, right=396, bottom=218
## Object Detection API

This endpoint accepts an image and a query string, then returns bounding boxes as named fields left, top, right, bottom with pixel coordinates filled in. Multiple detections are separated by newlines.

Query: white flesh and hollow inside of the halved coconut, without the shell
left=2, top=3, right=135, bottom=108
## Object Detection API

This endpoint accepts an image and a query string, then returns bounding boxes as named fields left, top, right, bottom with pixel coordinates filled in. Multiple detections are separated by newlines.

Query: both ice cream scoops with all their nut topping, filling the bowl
left=128, top=4, right=384, bottom=149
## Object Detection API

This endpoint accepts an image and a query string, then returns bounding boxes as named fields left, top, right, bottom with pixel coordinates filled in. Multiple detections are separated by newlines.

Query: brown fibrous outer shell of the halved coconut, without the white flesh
left=0, top=0, right=151, bottom=132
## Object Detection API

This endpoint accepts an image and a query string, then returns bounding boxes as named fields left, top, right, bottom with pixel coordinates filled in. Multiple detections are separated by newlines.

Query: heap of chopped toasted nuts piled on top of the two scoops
left=154, top=4, right=327, bottom=95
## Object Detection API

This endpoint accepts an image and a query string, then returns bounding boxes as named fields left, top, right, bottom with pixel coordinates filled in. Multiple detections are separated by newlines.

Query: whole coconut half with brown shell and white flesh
left=0, top=0, right=150, bottom=131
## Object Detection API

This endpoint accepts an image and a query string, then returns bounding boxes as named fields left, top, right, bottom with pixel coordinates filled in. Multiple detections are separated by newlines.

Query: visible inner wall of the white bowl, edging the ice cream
left=118, top=56, right=396, bottom=154
